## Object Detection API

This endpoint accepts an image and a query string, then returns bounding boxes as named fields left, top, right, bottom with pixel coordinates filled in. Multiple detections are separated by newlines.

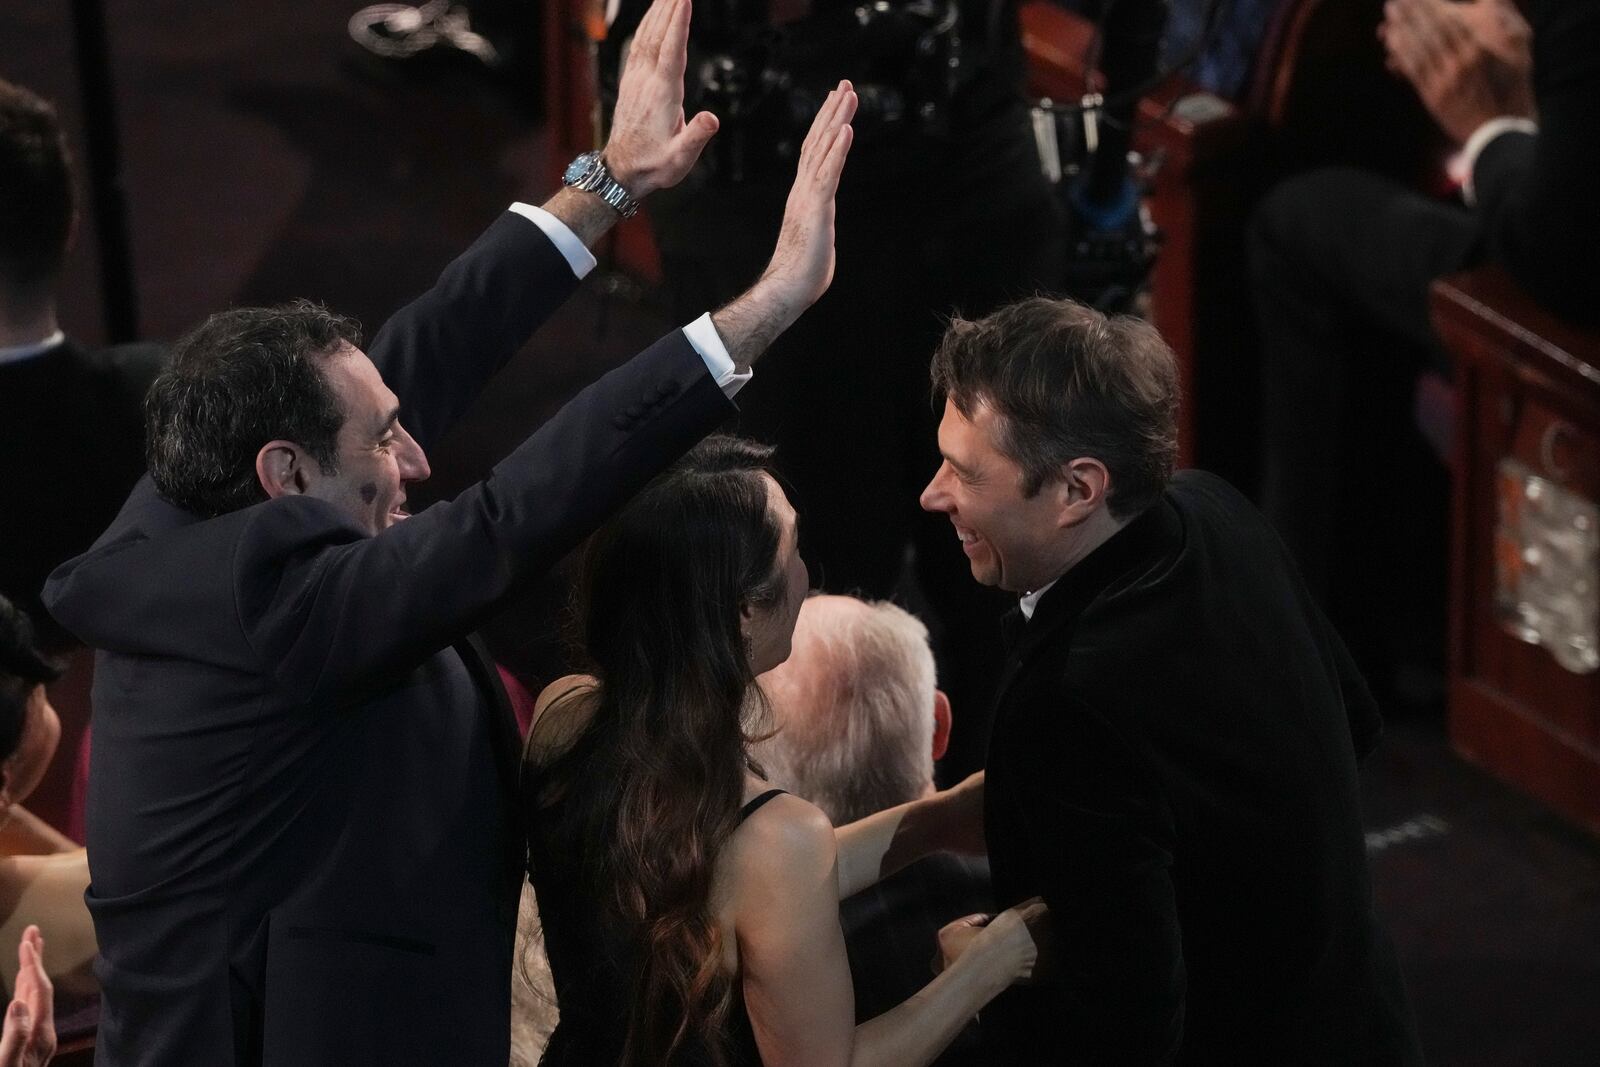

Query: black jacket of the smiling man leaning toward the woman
left=982, top=472, right=1419, bottom=1065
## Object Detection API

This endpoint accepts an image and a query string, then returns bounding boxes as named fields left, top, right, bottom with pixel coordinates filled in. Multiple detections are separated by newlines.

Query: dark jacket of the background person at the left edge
left=0, top=338, right=166, bottom=648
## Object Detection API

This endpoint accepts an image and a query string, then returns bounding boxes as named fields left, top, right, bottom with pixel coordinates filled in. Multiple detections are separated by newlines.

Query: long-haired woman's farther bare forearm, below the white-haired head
left=834, top=771, right=984, bottom=901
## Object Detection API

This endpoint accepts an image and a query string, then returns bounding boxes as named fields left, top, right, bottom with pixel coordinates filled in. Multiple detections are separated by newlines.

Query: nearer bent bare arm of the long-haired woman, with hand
left=726, top=797, right=1034, bottom=1067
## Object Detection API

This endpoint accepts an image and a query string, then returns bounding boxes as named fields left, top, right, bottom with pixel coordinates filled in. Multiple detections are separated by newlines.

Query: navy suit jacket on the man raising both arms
left=46, top=214, right=731, bottom=1067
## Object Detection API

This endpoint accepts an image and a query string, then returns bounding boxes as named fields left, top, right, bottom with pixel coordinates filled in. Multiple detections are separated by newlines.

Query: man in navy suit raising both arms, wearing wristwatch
left=46, top=0, right=854, bottom=1067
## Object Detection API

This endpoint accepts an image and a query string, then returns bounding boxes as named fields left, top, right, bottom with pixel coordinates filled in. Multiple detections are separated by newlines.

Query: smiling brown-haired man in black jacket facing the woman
left=922, top=299, right=1419, bottom=1064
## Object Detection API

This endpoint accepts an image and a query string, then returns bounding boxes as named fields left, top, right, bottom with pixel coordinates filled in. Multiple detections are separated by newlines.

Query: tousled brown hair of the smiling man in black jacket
left=931, top=296, right=1179, bottom=518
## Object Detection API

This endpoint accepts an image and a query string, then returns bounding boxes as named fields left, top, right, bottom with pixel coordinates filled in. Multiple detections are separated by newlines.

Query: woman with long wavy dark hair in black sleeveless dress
left=523, top=437, right=1035, bottom=1067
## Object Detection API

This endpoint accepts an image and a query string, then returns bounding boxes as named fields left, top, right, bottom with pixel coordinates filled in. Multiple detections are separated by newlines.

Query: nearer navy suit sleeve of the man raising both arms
left=232, top=331, right=733, bottom=699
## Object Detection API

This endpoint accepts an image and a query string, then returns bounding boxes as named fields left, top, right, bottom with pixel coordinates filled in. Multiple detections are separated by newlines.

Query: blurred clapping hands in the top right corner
left=1378, top=0, right=1534, bottom=142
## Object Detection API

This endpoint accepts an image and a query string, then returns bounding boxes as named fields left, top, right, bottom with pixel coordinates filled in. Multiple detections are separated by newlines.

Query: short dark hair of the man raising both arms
left=144, top=301, right=362, bottom=518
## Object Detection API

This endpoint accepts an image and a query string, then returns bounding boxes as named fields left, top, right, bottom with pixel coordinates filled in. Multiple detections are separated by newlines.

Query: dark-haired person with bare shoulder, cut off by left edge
left=0, top=597, right=99, bottom=1011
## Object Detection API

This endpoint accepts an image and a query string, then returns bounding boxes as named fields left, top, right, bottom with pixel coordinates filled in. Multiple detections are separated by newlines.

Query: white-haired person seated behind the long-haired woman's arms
left=752, top=597, right=994, bottom=1067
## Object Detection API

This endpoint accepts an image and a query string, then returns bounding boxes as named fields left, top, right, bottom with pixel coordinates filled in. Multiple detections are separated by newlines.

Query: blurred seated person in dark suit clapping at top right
left=1251, top=0, right=1600, bottom=681
